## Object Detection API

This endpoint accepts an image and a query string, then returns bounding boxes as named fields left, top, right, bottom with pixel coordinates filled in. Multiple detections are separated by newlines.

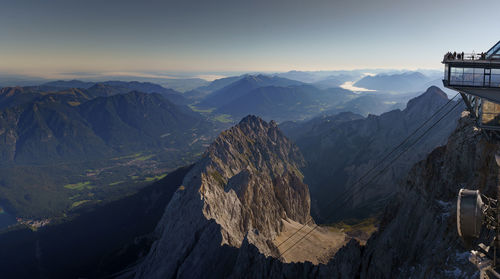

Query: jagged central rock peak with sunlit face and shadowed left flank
left=136, top=116, right=311, bottom=278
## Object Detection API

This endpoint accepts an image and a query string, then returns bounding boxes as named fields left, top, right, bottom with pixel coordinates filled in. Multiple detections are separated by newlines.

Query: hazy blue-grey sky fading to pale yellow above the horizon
left=0, top=0, right=500, bottom=75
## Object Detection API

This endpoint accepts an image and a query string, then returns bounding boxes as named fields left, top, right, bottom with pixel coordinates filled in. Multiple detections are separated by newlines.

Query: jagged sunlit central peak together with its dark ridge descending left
left=0, top=116, right=324, bottom=278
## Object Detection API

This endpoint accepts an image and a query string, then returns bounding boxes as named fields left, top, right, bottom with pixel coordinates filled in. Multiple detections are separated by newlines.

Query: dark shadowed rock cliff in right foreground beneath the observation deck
left=227, top=112, right=492, bottom=279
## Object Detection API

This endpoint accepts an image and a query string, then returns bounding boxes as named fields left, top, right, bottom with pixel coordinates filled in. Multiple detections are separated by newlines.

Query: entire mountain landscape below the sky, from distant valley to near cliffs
left=0, top=65, right=488, bottom=279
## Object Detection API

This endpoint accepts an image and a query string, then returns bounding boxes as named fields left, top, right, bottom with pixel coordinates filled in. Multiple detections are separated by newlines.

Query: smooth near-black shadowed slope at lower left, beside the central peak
left=0, top=167, right=190, bottom=279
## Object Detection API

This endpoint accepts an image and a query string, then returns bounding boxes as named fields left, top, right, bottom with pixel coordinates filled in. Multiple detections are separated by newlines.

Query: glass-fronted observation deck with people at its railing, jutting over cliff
left=442, top=42, right=500, bottom=130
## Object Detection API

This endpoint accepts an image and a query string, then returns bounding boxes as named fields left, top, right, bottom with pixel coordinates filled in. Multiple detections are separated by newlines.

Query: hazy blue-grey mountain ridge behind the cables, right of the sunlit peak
left=282, top=87, right=463, bottom=222
